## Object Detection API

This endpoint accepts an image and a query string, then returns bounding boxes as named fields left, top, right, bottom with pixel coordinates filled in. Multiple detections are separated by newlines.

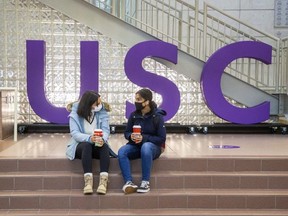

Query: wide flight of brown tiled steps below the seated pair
left=0, top=157, right=288, bottom=216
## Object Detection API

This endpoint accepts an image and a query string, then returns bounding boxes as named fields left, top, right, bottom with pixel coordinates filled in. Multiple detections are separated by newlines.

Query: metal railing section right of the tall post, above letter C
left=203, top=3, right=286, bottom=93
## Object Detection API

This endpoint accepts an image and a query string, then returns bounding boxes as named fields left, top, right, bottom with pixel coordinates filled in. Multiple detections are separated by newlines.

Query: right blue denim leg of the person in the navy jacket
left=141, top=142, right=161, bottom=181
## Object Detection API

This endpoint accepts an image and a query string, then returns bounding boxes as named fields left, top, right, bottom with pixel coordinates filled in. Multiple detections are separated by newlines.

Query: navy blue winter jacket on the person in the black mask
left=124, top=108, right=166, bottom=147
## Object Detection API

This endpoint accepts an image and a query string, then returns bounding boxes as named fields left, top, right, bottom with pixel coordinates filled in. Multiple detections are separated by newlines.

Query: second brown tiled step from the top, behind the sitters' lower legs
left=0, top=171, right=288, bottom=190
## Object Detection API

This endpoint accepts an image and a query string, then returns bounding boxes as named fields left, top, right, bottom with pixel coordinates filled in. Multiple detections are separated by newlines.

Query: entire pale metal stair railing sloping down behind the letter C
left=85, top=0, right=288, bottom=93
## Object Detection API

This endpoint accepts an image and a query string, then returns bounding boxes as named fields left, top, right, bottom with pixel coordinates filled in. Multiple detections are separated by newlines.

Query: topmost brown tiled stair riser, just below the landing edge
left=0, top=156, right=288, bottom=172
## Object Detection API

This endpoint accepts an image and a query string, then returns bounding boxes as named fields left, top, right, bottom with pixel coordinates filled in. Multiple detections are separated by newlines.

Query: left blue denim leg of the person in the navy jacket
left=118, top=144, right=140, bottom=182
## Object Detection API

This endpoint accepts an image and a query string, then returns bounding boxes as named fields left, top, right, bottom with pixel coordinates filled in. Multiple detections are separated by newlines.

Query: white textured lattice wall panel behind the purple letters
left=0, top=0, right=227, bottom=125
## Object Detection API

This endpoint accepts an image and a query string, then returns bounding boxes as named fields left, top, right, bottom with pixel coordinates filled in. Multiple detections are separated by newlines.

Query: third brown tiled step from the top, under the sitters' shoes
left=0, top=189, right=288, bottom=210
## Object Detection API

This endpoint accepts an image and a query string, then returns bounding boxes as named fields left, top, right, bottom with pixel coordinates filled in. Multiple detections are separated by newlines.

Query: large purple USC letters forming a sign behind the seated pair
left=26, top=40, right=272, bottom=124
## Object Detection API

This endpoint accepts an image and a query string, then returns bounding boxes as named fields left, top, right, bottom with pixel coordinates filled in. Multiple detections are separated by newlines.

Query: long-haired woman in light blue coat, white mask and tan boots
left=66, top=91, right=110, bottom=194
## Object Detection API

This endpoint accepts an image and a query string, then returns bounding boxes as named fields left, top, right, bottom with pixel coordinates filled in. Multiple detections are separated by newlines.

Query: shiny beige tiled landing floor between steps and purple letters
left=0, top=133, right=288, bottom=158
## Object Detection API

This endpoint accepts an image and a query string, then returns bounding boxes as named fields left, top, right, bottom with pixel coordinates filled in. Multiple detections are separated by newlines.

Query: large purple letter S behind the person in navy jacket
left=124, top=41, right=180, bottom=121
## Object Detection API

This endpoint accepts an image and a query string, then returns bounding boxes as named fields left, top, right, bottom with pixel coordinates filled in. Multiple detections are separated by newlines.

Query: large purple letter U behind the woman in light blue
left=26, top=40, right=98, bottom=124
